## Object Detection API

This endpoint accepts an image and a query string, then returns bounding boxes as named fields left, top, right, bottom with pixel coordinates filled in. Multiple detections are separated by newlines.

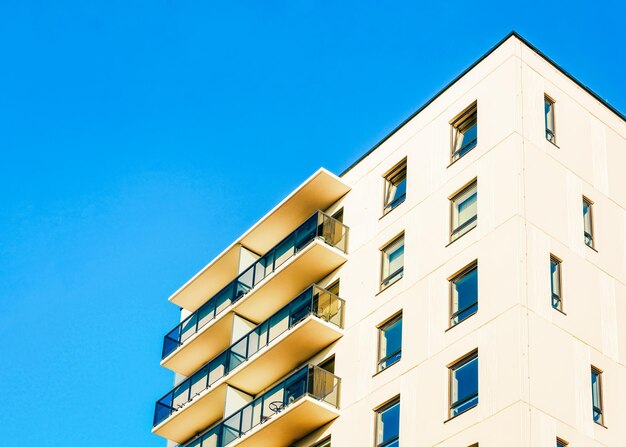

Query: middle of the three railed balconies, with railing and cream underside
left=153, top=285, right=345, bottom=442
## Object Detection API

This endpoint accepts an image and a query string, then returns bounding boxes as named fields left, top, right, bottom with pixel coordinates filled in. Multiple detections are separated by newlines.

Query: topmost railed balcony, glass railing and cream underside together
left=161, top=211, right=348, bottom=376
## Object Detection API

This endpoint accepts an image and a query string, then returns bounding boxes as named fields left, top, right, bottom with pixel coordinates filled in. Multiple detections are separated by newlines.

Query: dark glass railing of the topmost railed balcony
left=162, top=211, right=348, bottom=358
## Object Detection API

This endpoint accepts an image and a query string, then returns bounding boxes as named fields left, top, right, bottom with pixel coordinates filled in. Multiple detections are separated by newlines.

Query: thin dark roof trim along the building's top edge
left=339, top=31, right=626, bottom=177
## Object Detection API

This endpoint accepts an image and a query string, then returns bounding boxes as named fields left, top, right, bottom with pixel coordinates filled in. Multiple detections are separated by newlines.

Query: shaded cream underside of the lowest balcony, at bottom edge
left=228, top=396, right=339, bottom=447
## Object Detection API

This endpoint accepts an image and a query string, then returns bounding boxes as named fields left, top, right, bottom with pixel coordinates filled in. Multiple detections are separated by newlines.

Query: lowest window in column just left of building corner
left=449, top=351, right=478, bottom=417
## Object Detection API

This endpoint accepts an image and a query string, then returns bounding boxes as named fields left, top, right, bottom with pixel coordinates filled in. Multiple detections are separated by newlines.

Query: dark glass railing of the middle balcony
left=154, top=285, right=344, bottom=426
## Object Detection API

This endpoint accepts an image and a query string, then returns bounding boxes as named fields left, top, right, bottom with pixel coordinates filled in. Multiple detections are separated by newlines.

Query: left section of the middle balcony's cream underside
left=152, top=382, right=227, bottom=444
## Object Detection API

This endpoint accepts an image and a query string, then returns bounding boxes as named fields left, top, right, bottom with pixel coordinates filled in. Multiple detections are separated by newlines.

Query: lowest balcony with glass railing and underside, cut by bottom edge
left=179, top=365, right=341, bottom=447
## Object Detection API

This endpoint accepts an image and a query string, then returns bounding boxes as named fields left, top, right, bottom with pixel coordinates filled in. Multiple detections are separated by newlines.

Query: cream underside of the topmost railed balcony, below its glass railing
left=161, top=240, right=347, bottom=376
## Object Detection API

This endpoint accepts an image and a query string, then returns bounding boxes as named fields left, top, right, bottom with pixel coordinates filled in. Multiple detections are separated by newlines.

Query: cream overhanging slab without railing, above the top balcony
left=169, top=169, right=350, bottom=311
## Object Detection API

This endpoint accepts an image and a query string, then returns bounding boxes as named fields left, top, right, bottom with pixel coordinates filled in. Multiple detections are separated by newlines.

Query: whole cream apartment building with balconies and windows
left=153, top=33, right=626, bottom=447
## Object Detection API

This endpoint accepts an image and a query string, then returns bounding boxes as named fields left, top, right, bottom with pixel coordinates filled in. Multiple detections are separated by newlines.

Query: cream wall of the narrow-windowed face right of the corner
left=521, top=36, right=626, bottom=446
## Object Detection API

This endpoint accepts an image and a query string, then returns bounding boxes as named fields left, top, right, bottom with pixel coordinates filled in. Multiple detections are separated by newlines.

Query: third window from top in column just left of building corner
left=450, top=262, right=478, bottom=326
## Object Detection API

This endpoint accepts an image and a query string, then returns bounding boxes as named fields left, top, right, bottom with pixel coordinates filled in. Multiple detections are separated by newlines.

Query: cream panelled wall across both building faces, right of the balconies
left=298, top=38, right=626, bottom=447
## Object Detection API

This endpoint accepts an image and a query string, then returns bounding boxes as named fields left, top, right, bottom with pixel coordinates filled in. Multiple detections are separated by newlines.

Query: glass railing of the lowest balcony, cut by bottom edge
left=178, top=365, right=341, bottom=447
